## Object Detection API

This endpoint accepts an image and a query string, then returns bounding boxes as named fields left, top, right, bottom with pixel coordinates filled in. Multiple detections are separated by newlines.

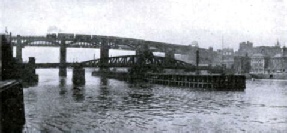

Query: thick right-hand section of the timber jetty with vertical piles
left=146, top=73, right=246, bottom=91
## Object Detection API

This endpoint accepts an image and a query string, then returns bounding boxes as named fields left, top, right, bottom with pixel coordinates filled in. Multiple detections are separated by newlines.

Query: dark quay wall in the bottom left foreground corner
left=0, top=80, right=25, bottom=133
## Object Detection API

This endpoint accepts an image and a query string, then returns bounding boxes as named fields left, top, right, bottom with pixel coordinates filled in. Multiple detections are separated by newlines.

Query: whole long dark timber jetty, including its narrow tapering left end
left=92, top=72, right=246, bottom=91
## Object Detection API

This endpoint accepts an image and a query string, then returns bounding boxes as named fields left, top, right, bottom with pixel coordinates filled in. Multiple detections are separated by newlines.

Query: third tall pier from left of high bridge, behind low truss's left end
left=100, top=40, right=109, bottom=71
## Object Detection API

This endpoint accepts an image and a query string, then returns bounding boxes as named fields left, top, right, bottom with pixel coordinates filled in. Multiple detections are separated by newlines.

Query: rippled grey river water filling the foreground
left=24, top=69, right=287, bottom=133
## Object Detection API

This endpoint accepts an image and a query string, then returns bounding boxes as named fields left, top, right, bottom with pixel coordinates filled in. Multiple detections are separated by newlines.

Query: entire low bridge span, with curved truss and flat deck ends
left=35, top=55, right=221, bottom=71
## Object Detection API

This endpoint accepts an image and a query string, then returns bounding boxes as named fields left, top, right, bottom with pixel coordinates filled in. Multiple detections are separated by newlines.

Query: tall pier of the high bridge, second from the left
left=59, top=40, right=67, bottom=76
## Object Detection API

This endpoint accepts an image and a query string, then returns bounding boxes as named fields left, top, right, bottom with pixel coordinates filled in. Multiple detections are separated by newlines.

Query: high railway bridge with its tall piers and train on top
left=11, top=33, right=212, bottom=76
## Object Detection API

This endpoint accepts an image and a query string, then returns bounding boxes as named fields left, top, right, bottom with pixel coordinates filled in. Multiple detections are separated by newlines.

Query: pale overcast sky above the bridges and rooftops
left=0, top=0, right=287, bottom=49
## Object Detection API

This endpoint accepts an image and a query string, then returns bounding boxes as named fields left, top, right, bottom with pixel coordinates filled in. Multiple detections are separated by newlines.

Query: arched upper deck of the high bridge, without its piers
left=11, top=33, right=188, bottom=53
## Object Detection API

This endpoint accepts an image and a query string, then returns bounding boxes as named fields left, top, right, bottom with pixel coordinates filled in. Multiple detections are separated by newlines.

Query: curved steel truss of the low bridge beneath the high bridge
left=81, top=55, right=195, bottom=69
